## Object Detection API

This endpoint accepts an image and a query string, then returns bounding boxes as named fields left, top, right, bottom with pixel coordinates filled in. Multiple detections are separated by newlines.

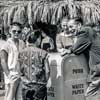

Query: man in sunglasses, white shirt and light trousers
left=0, top=22, right=25, bottom=100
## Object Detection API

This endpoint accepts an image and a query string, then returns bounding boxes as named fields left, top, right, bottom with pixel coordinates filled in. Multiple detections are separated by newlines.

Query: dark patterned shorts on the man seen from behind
left=22, top=83, right=47, bottom=100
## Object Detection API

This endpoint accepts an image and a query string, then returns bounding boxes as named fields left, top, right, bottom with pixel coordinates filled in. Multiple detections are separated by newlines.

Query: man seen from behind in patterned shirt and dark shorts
left=19, top=31, right=50, bottom=100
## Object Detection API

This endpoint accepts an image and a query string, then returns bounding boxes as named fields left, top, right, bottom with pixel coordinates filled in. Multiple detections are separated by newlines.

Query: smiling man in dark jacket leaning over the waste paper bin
left=68, top=18, right=100, bottom=97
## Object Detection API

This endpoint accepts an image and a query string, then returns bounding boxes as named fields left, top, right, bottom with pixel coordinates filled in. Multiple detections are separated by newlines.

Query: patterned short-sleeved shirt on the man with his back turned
left=19, top=46, right=47, bottom=83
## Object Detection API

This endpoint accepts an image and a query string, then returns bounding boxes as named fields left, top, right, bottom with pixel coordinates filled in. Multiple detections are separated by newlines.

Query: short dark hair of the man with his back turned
left=27, top=30, right=41, bottom=43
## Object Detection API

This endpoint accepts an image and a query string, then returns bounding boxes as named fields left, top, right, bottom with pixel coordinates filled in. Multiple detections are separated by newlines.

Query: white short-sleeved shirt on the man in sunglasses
left=1, top=38, right=25, bottom=71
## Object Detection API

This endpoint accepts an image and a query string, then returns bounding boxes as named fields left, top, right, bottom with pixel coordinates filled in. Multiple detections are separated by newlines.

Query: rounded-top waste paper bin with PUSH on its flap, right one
left=62, top=54, right=89, bottom=100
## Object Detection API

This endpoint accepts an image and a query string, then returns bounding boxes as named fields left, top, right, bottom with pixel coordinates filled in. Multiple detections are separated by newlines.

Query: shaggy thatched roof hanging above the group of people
left=0, top=0, right=100, bottom=27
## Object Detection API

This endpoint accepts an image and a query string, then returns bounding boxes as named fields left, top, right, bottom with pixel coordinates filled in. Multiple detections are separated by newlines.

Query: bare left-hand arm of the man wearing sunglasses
left=0, top=50, right=10, bottom=76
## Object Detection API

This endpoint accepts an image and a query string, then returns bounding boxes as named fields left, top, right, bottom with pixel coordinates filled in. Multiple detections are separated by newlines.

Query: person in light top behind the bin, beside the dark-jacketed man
left=56, top=18, right=74, bottom=54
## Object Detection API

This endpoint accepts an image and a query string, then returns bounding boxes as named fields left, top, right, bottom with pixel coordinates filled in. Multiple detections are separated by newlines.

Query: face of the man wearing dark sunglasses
left=9, top=25, right=21, bottom=39
